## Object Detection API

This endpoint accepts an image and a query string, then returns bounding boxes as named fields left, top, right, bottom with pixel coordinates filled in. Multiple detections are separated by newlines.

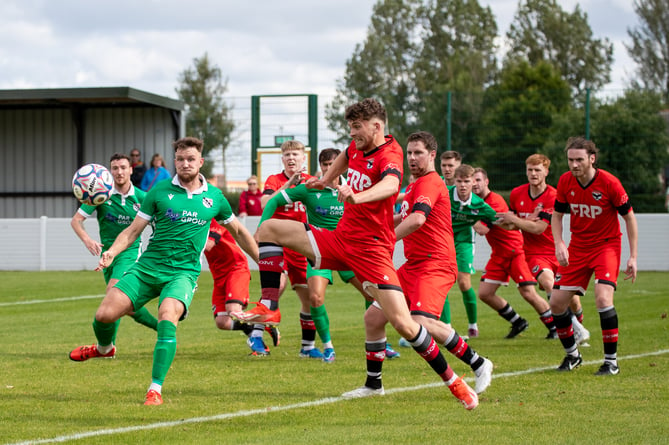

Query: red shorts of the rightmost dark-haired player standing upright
left=553, top=240, right=621, bottom=295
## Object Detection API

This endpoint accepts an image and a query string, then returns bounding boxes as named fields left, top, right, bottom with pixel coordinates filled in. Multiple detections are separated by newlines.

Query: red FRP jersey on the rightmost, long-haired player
left=555, top=169, right=632, bottom=248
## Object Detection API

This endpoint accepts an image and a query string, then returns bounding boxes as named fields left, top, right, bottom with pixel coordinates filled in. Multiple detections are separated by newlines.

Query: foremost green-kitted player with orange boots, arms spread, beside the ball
left=70, top=137, right=258, bottom=405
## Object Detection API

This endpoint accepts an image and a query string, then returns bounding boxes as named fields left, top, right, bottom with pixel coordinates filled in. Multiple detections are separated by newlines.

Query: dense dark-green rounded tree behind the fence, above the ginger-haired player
left=479, top=60, right=571, bottom=190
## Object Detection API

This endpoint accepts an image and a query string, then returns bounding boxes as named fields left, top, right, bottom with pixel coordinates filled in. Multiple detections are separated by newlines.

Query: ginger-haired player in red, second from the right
left=497, top=154, right=590, bottom=344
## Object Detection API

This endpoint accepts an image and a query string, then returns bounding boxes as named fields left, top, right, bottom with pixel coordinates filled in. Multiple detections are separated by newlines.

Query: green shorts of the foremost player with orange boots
left=114, top=267, right=197, bottom=320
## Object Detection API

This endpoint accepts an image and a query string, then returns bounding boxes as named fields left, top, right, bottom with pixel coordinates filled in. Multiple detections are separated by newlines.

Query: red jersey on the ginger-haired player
left=509, top=184, right=556, bottom=256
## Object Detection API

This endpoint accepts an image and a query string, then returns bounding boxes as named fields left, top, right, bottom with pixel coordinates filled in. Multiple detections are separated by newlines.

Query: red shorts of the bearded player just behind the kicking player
left=397, top=261, right=458, bottom=319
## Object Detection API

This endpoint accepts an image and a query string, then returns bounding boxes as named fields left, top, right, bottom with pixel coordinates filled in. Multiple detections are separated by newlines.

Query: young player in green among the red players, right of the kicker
left=441, top=164, right=496, bottom=338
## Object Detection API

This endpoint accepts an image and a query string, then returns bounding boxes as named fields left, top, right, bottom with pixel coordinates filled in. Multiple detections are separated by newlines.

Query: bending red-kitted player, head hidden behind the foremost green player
left=204, top=220, right=280, bottom=346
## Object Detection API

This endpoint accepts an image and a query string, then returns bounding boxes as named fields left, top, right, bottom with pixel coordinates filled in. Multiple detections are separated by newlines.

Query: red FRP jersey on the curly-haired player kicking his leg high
left=336, top=135, right=404, bottom=252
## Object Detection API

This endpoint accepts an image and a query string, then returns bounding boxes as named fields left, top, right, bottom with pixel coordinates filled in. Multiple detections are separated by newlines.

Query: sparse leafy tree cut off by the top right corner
left=625, top=0, right=669, bottom=103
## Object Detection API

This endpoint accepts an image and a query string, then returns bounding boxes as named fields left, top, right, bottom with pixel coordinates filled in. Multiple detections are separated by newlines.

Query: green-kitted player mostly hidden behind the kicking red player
left=258, top=148, right=392, bottom=363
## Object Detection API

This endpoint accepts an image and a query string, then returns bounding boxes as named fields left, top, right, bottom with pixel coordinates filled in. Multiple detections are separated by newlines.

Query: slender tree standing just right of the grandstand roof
left=176, top=53, right=235, bottom=177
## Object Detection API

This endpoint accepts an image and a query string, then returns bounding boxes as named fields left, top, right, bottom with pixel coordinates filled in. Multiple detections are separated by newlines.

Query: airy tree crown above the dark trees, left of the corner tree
left=507, top=0, right=613, bottom=96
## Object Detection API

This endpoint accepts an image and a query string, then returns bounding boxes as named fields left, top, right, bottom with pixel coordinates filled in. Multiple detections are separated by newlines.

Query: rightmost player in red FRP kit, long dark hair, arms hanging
left=551, top=137, right=638, bottom=375
